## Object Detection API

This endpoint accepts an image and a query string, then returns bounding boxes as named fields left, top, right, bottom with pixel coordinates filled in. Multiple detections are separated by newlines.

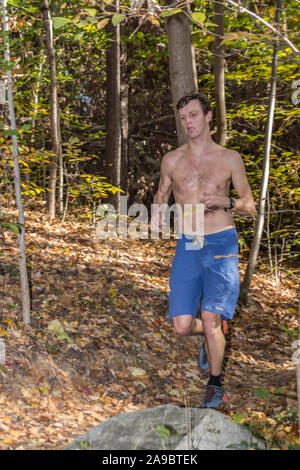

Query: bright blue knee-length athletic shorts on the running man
left=169, top=228, right=240, bottom=321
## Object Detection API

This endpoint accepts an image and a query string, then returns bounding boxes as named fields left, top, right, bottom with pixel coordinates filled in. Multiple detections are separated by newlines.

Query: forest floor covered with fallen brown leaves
left=0, top=210, right=298, bottom=449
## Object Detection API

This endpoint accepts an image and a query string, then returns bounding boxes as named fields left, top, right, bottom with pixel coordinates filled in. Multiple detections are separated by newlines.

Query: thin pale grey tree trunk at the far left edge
left=2, top=0, right=30, bottom=325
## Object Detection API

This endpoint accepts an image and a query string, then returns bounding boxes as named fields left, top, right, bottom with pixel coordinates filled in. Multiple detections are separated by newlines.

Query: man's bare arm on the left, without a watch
left=150, top=153, right=172, bottom=231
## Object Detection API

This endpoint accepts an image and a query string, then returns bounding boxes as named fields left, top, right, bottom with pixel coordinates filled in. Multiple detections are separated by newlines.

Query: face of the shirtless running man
left=179, top=100, right=212, bottom=139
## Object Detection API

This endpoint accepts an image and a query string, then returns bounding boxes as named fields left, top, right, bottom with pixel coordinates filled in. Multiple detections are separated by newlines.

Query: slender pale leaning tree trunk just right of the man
left=240, top=0, right=282, bottom=305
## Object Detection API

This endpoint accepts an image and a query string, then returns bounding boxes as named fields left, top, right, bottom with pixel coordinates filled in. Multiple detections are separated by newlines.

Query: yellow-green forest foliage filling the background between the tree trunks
left=0, top=0, right=300, bottom=276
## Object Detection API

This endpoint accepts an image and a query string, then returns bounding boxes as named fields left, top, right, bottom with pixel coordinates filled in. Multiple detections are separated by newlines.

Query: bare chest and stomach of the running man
left=169, top=143, right=234, bottom=234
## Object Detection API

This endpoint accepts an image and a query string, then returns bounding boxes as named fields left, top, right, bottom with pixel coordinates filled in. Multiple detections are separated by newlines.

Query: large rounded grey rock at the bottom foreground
left=66, top=405, right=264, bottom=450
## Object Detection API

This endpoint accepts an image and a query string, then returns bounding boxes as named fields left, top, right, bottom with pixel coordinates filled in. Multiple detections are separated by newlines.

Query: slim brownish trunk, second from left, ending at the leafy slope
left=42, top=0, right=61, bottom=220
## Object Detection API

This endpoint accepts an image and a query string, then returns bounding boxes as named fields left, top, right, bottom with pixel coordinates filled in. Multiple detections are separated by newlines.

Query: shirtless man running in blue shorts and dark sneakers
left=151, top=93, right=257, bottom=408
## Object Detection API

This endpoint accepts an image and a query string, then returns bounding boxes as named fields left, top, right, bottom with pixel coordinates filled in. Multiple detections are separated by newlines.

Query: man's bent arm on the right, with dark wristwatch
left=229, top=152, right=257, bottom=216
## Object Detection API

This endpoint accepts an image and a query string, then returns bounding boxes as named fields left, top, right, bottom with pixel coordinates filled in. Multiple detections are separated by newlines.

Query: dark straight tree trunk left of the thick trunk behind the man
left=105, top=0, right=122, bottom=211
